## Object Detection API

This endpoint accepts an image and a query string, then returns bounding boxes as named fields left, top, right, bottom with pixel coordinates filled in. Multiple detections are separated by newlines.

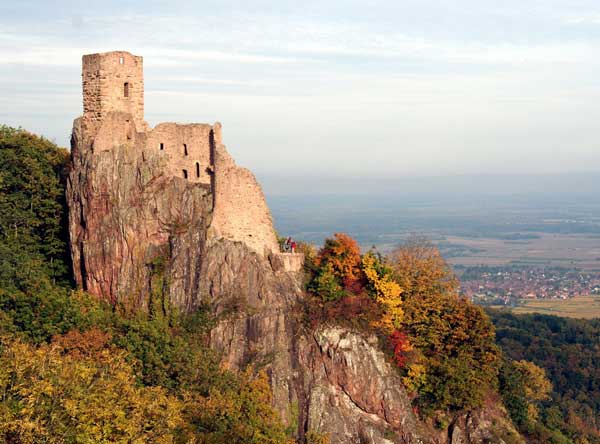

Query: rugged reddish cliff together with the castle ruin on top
left=67, top=52, right=524, bottom=444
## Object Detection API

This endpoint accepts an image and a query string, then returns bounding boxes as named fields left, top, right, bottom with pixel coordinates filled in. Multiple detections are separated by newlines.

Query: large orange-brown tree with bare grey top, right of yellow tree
left=390, top=238, right=500, bottom=414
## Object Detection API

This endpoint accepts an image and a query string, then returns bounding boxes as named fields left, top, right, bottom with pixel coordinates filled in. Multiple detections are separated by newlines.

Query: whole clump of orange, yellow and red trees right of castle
left=307, top=234, right=545, bottom=426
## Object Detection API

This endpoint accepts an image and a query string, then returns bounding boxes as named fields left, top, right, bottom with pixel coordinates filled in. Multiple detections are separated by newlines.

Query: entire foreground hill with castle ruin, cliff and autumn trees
left=0, top=52, right=592, bottom=444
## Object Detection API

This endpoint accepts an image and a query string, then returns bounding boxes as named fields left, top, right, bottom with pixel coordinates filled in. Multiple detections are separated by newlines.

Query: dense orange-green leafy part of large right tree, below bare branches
left=404, top=293, right=500, bottom=414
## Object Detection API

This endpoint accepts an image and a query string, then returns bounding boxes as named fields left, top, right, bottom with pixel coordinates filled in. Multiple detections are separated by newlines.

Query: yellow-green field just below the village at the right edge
left=512, top=296, right=600, bottom=319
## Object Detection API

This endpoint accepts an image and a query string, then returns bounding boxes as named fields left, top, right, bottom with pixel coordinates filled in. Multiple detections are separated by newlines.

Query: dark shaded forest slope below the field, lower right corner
left=489, top=310, right=600, bottom=443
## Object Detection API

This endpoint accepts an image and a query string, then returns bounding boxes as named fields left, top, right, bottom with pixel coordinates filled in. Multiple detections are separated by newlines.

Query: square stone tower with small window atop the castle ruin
left=82, top=51, right=144, bottom=131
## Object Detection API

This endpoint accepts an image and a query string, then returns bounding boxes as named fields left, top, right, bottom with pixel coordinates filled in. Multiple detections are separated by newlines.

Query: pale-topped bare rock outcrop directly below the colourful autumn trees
left=299, top=327, right=429, bottom=444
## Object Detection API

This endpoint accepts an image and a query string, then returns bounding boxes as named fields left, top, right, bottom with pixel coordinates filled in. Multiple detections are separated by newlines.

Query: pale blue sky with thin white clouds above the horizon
left=0, top=0, right=600, bottom=178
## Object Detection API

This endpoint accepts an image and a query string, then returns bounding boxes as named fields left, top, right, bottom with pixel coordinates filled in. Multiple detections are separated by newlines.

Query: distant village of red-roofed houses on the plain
left=456, top=266, right=600, bottom=306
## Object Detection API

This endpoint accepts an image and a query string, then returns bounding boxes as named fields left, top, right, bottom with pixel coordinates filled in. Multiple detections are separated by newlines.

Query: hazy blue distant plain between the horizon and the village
left=265, top=174, right=600, bottom=271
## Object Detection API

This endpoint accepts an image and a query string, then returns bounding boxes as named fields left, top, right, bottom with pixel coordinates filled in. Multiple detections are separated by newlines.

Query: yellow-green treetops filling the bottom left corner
left=0, top=341, right=182, bottom=444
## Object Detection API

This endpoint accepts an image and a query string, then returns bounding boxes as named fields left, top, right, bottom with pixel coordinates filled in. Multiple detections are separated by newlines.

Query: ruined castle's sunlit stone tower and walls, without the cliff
left=83, top=51, right=279, bottom=255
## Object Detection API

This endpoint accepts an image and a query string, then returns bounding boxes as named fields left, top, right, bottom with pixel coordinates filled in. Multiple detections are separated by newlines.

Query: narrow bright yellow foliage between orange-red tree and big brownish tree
left=362, top=253, right=404, bottom=334
